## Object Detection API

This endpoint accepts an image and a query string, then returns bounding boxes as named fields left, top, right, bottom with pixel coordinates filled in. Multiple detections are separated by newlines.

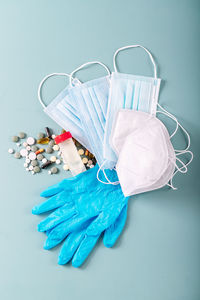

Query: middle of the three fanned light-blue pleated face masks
left=66, top=62, right=110, bottom=168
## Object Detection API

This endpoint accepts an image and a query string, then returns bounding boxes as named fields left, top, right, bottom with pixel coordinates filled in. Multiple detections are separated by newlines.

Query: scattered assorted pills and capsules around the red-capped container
left=8, top=127, right=96, bottom=175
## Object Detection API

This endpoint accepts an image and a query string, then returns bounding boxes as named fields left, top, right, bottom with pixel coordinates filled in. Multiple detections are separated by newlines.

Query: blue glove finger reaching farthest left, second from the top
left=32, top=191, right=71, bottom=215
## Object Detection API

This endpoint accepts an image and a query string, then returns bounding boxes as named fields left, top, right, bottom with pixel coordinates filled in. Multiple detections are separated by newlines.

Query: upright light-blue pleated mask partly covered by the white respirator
left=104, top=45, right=161, bottom=167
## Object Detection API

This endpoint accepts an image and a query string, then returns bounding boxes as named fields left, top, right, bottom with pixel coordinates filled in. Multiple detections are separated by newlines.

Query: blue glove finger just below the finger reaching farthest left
left=38, top=203, right=76, bottom=232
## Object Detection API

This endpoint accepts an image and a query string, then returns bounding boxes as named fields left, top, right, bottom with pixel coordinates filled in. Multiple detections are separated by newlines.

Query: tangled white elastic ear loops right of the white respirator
left=157, top=103, right=194, bottom=190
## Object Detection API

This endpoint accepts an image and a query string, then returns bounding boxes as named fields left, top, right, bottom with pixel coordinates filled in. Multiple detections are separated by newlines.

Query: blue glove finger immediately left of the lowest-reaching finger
left=58, top=222, right=90, bottom=265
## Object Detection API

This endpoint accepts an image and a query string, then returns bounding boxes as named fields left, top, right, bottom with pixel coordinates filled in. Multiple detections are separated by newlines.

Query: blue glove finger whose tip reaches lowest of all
left=72, top=234, right=100, bottom=268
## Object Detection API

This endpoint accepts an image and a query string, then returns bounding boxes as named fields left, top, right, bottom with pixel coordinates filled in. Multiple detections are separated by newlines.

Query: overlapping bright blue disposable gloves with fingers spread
left=33, top=166, right=128, bottom=266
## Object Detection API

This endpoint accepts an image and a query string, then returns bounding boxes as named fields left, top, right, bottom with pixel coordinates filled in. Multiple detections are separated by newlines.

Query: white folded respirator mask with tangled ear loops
left=111, top=106, right=193, bottom=196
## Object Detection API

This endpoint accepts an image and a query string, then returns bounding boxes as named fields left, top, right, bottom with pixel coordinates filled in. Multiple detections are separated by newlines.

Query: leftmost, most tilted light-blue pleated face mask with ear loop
left=38, top=73, right=91, bottom=151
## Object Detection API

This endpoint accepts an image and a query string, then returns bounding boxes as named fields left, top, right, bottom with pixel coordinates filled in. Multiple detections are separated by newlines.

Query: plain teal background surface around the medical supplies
left=0, top=0, right=200, bottom=300
